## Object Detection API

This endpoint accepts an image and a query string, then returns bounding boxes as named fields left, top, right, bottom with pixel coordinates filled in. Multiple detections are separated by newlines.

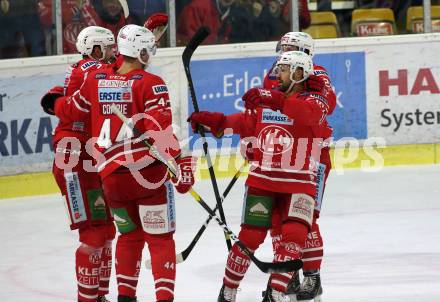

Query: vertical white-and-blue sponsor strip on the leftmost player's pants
left=64, top=172, right=87, bottom=223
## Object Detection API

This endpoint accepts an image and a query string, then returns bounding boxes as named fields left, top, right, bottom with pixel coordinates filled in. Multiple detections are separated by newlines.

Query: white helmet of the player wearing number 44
left=118, top=24, right=157, bottom=65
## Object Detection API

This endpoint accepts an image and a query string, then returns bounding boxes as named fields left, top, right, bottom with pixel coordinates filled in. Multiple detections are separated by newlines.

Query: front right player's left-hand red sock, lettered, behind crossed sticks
left=223, top=226, right=267, bottom=288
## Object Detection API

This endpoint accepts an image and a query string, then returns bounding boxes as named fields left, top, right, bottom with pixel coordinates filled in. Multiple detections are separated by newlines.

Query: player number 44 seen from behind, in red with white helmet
left=47, top=25, right=194, bottom=302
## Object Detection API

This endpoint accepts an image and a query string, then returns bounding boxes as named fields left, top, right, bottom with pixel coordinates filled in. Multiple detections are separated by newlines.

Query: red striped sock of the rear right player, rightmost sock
left=303, top=221, right=324, bottom=272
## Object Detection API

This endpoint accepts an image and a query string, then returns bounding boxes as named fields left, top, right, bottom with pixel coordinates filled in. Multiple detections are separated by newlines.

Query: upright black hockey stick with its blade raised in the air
left=182, top=26, right=232, bottom=251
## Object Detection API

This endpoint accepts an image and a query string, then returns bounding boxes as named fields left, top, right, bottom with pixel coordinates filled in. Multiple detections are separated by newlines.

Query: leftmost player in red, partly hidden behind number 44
left=41, top=26, right=116, bottom=302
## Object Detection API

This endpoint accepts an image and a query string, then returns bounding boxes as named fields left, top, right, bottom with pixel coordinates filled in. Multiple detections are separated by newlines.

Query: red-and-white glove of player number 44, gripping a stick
left=171, top=156, right=197, bottom=194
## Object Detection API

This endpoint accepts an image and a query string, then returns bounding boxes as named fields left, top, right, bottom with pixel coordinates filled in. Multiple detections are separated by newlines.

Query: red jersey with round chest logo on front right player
left=223, top=92, right=332, bottom=196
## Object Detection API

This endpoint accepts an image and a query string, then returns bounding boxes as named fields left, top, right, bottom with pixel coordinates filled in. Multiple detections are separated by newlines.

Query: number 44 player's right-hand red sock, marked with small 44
left=144, top=233, right=176, bottom=301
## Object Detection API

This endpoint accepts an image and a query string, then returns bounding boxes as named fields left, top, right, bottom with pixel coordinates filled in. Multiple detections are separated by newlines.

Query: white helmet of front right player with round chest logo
left=275, top=51, right=313, bottom=91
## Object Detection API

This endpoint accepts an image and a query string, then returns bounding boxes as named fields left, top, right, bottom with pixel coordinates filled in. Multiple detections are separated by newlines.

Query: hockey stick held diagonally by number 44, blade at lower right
left=111, top=104, right=303, bottom=274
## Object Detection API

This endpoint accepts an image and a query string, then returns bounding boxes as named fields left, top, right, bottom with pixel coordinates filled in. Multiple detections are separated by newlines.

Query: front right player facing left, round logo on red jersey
left=189, top=51, right=331, bottom=302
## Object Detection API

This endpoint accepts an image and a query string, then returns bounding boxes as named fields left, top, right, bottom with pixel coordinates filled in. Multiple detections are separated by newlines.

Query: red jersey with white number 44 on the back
left=55, top=66, right=180, bottom=179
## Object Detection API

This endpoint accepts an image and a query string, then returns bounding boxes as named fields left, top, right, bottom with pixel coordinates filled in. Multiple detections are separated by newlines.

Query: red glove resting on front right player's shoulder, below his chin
left=241, top=87, right=286, bottom=110
